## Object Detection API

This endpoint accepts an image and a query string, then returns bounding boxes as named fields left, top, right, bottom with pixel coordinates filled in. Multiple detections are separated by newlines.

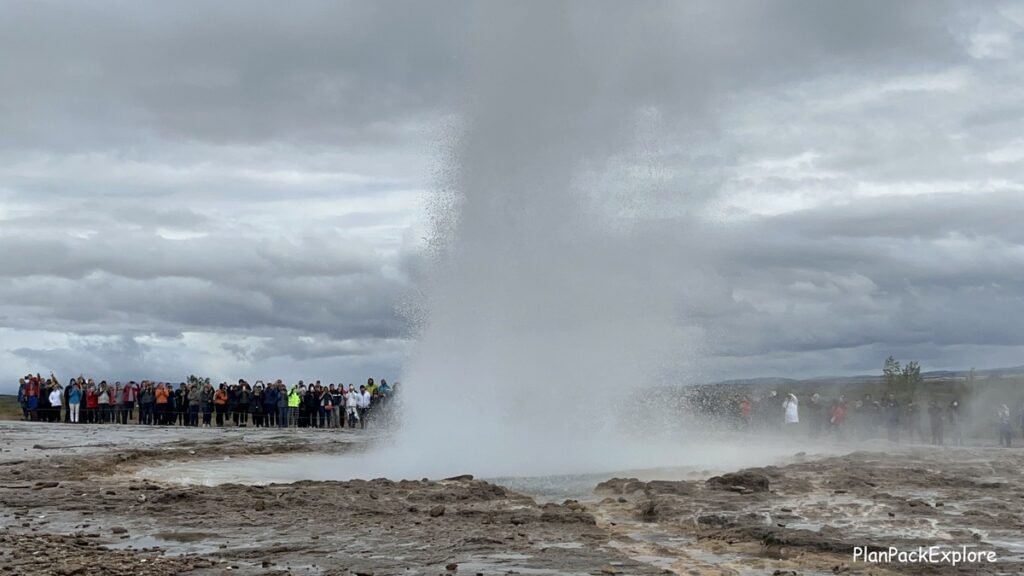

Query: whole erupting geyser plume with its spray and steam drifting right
left=366, top=2, right=937, bottom=477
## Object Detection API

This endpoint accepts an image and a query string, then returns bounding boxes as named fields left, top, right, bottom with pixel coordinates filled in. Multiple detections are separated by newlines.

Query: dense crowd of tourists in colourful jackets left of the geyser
left=17, top=374, right=398, bottom=428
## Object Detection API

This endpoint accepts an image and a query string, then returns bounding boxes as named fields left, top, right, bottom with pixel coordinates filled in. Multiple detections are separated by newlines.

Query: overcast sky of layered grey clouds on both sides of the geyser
left=0, top=1, right=1024, bottom=388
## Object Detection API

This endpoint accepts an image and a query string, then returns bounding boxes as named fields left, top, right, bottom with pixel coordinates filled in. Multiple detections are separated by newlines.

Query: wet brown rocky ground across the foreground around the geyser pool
left=0, top=422, right=1024, bottom=575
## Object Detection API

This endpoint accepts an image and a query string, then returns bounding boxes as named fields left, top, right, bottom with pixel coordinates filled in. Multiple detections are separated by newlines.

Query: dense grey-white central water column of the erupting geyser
left=389, top=3, right=685, bottom=475
